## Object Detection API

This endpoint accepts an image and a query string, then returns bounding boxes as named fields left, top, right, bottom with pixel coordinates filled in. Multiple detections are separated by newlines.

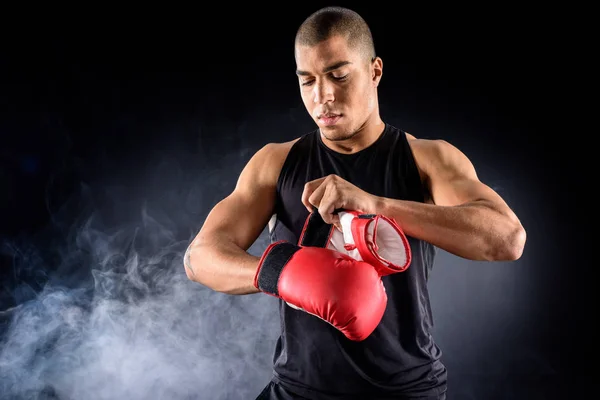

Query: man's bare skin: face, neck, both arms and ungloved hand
left=184, top=36, right=526, bottom=295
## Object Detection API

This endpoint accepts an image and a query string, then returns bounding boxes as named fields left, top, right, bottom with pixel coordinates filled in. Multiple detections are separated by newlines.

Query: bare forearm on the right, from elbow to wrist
left=376, top=198, right=524, bottom=261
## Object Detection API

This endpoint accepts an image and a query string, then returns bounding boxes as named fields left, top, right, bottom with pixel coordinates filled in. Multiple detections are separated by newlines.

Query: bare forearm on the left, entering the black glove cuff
left=184, top=238, right=260, bottom=295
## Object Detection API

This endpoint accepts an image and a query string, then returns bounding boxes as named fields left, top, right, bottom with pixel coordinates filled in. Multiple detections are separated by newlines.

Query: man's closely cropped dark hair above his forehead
left=295, top=7, right=375, bottom=61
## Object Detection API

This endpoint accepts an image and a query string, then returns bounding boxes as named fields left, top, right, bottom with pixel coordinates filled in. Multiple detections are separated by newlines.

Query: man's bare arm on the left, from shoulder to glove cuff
left=184, top=144, right=284, bottom=295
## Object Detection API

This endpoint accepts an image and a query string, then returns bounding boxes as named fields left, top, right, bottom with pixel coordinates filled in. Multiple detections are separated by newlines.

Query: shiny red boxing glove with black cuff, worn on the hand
left=254, top=219, right=387, bottom=341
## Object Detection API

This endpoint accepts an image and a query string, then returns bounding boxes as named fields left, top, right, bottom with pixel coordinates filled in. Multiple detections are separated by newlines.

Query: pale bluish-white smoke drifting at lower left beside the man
left=0, top=152, right=279, bottom=400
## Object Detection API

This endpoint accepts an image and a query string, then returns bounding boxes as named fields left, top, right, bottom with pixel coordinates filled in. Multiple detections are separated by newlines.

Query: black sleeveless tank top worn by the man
left=270, top=124, right=446, bottom=400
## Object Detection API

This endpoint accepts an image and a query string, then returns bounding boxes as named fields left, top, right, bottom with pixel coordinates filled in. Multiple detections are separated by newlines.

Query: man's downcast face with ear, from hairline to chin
left=296, top=36, right=382, bottom=141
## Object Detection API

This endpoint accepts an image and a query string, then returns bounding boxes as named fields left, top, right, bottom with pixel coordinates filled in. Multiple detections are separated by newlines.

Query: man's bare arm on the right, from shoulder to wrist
left=375, top=140, right=526, bottom=261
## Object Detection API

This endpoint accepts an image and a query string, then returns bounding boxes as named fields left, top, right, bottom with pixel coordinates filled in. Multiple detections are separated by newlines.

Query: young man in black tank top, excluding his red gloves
left=185, top=7, right=526, bottom=400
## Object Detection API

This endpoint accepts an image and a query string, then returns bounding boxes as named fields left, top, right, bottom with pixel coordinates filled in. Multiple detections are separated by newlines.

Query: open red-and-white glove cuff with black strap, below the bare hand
left=299, top=211, right=411, bottom=276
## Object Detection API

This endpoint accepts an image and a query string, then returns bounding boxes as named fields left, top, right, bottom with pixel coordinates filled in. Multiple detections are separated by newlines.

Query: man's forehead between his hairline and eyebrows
left=296, top=36, right=357, bottom=70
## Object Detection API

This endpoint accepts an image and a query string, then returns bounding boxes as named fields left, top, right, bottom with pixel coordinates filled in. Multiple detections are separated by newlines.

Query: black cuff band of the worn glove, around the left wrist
left=254, top=240, right=300, bottom=297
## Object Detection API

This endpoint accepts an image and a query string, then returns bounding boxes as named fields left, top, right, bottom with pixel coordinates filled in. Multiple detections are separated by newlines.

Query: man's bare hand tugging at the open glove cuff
left=302, top=175, right=377, bottom=230
